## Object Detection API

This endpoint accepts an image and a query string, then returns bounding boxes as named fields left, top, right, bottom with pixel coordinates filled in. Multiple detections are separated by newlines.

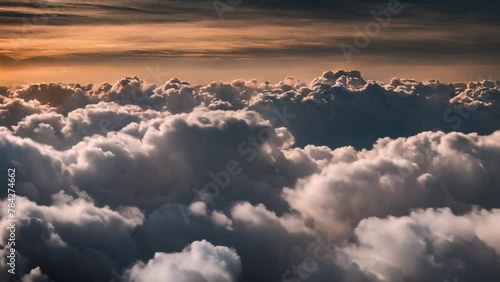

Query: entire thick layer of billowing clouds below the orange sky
left=0, top=71, right=500, bottom=282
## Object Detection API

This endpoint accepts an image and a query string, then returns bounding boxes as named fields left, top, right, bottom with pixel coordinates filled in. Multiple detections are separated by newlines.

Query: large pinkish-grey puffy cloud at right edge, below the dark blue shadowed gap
left=284, top=131, right=500, bottom=236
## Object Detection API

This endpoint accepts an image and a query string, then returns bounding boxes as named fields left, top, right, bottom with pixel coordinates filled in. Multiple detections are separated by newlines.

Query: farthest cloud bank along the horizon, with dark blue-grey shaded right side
left=0, top=70, right=500, bottom=148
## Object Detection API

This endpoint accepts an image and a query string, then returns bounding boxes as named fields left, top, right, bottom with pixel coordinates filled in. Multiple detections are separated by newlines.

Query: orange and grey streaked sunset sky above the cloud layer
left=0, top=0, right=500, bottom=85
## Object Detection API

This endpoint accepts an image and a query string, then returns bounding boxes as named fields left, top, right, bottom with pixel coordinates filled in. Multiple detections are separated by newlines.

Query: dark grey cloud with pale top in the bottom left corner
left=0, top=192, right=144, bottom=281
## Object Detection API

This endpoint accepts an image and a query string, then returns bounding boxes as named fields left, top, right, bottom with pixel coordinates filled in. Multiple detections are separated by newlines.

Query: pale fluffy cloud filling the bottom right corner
left=341, top=208, right=500, bottom=281
